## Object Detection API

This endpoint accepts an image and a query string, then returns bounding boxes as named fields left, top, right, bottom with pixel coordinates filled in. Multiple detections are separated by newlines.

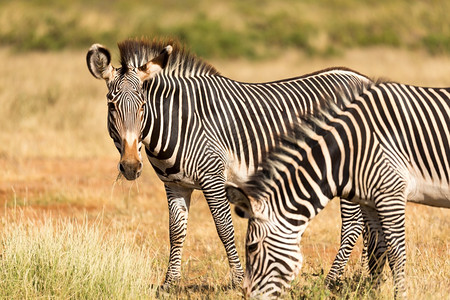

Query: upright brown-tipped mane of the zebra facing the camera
left=118, top=38, right=219, bottom=77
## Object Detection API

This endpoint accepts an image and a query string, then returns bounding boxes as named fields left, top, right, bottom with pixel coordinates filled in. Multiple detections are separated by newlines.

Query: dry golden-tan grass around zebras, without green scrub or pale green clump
left=0, top=48, right=450, bottom=299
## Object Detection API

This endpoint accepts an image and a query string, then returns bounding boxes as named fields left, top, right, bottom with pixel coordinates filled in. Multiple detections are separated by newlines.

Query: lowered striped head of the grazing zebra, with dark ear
left=226, top=185, right=303, bottom=299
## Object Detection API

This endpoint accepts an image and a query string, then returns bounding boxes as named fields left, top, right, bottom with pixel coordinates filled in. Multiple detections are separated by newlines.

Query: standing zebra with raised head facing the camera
left=86, top=39, right=371, bottom=287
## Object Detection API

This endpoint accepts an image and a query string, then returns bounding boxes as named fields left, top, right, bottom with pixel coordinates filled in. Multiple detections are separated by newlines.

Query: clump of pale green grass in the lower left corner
left=0, top=212, right=162, bottom=299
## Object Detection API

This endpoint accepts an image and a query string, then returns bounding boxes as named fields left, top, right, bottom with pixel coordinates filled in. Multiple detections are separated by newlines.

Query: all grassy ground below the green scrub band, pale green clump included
left=0, top=48, right=450, bottom=299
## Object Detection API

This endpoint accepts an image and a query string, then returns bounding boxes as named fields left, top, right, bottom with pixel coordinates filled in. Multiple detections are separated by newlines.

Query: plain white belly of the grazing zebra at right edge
left=407, top=176, right=450, bottom=208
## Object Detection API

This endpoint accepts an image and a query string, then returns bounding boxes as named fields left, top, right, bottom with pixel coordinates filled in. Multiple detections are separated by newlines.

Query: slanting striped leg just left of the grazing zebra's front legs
left=325, top=199, right=364, bottom=288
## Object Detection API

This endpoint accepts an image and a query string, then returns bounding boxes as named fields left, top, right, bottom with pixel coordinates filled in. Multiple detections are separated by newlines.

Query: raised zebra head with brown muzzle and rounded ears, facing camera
left=86, top=44, right=172, bottom=180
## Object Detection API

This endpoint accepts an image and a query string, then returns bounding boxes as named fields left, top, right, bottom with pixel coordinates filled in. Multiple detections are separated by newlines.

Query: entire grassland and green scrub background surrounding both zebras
left=0, top=0, right=450, bottom=299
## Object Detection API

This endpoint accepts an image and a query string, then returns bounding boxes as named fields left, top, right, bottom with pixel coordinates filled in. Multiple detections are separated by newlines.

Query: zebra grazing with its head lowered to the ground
left=226, top=83, right=450, bottom=297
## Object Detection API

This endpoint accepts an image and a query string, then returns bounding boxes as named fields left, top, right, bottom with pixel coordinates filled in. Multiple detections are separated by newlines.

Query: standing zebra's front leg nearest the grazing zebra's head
left=202, top=176, right=244, bottom=287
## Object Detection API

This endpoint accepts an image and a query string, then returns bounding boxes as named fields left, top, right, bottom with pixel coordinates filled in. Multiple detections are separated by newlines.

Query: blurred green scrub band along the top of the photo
left=0, top=0, right=450, bottom=58
